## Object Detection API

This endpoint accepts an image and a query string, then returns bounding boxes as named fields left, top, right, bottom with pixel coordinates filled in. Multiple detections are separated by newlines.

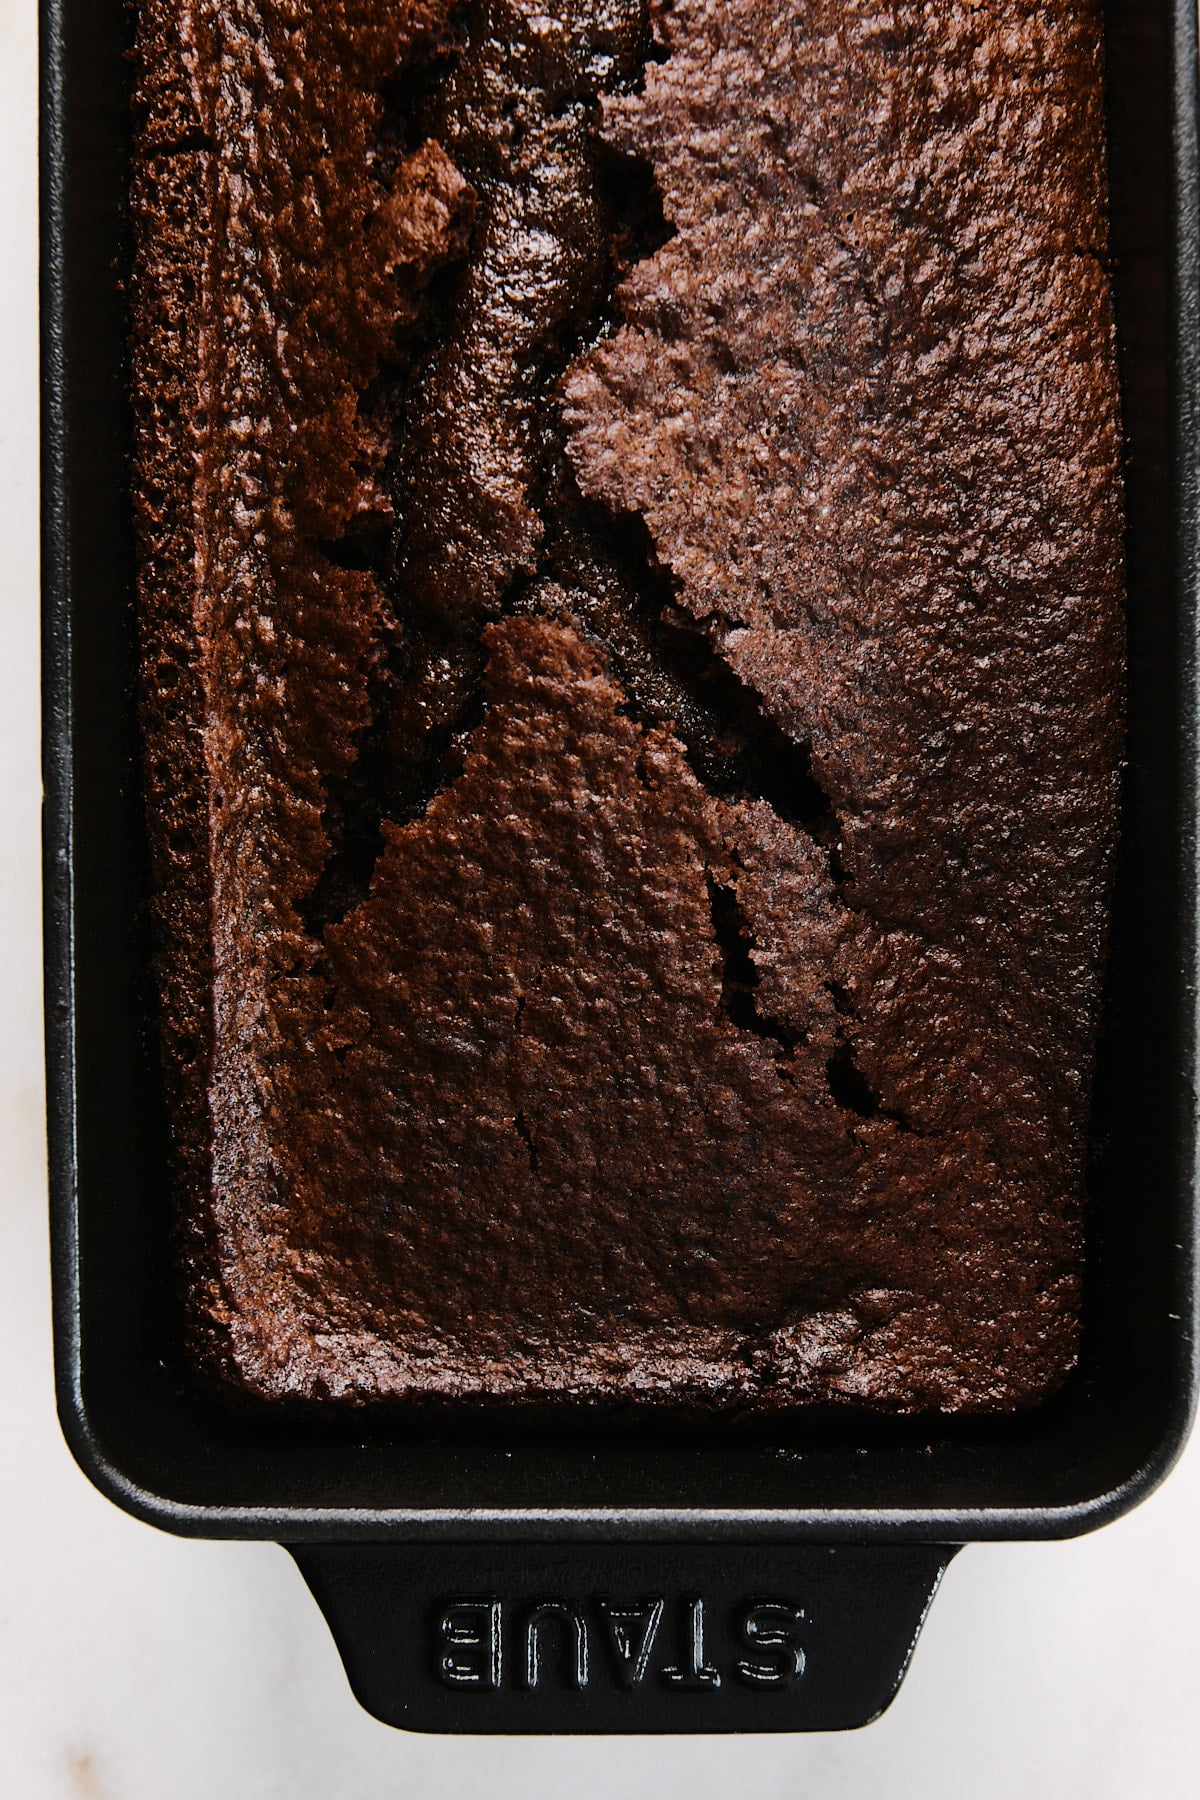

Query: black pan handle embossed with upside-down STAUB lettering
left=286, top=1541, right=957, bottom=1733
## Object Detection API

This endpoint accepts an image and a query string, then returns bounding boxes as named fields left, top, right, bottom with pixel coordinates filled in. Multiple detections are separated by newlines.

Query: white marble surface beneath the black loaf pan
left=0, top=0, right=1200, bottom=1800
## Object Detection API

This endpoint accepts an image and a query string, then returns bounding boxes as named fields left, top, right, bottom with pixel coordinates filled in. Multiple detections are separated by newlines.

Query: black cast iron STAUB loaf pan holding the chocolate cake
left=41, top=0, right=1200, bottom=1732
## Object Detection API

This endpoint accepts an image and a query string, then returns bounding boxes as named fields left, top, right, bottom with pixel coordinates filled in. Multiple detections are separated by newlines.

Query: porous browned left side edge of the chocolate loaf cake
left=131, top=14, right=219, bottom=1354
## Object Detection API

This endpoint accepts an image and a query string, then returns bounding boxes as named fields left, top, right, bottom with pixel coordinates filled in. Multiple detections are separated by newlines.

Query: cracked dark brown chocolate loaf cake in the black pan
left=131, top=0, right=1123, bottom=1415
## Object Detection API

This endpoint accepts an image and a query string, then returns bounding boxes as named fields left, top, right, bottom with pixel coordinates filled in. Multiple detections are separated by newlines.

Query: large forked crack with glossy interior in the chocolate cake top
left=304, top=0, right=837, bottom=932
